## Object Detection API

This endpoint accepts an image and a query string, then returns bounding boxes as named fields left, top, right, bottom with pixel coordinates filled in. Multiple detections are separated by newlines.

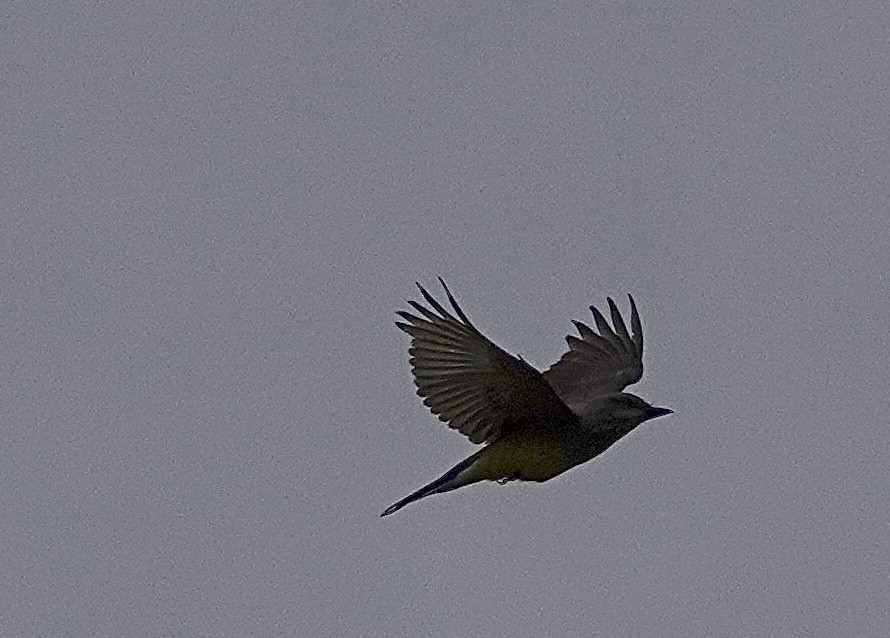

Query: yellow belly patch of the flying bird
left=469, top=436, right=572, bottom=481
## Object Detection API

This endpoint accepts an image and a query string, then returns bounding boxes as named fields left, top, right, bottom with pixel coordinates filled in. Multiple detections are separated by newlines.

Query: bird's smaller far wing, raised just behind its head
left=544, top=295, right=643, bottom=404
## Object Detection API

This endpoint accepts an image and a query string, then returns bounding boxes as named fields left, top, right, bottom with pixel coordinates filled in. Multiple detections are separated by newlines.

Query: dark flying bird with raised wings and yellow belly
left=381, top=277, right=673, bottom=516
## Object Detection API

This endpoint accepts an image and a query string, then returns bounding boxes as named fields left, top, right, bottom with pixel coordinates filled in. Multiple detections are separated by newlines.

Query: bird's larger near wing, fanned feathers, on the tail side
left=396, top=277, right=574, bottom=443
